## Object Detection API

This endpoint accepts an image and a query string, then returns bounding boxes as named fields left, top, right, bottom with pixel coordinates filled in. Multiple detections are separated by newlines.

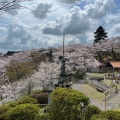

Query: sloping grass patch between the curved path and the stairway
left=83, top=84, right=105, bottom=101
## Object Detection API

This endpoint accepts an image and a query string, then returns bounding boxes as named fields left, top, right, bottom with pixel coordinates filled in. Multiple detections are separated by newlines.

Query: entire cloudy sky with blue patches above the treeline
left=0, top=0, right=120, bottom=52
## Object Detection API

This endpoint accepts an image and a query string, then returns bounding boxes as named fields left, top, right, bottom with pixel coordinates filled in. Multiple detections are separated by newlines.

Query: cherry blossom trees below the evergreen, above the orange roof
left=91, top=38, right=120, bottom=61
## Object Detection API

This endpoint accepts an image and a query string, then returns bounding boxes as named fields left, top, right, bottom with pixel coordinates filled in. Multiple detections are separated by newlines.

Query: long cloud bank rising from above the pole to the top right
left=43, top=0, right=114, bottom=35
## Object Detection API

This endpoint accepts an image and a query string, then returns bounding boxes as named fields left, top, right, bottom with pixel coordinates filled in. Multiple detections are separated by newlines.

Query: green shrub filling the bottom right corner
left=106, top=110, right=120, bottom=120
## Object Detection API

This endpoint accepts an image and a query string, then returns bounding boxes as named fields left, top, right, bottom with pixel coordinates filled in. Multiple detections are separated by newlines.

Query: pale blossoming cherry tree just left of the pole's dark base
left=32, top=62, right=60, bottom=85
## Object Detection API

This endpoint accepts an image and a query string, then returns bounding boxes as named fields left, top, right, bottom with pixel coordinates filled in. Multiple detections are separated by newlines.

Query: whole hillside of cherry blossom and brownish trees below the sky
left=0, top=38, right=120, bottom=100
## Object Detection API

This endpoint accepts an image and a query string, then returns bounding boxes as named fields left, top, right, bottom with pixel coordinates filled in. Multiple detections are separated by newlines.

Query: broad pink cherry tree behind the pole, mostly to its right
left=53, top=44, right=95, bottom=71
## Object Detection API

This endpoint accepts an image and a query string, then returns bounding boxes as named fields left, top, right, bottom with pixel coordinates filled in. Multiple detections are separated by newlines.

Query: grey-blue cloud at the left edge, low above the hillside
left=0, top=23, right=31, bottom=49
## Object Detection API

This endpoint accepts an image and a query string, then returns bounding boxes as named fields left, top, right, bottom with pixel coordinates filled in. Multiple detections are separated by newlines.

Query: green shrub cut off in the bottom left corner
left=0, top=106, right=9, bottom=120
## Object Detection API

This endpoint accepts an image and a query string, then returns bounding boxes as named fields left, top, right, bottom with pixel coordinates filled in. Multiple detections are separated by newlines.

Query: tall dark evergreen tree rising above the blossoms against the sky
left=94, top=26, right=108, bottom=43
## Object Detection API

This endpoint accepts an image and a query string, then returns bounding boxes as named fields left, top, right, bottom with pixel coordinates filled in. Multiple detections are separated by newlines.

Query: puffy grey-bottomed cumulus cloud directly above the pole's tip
left=43, top=7, right=90, bottom=35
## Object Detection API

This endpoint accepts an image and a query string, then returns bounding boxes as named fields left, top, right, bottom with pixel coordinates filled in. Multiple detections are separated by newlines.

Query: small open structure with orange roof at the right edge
left=105, top=61, right=120, bottom=79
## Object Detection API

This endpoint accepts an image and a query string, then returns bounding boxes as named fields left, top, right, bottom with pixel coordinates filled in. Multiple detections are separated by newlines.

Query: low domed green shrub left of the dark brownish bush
left=17, top=96, right=37, bottom=104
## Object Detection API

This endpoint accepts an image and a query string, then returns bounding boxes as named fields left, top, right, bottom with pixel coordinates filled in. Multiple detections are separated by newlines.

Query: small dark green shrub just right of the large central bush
left=85, top=105, right=101, bottom=120
